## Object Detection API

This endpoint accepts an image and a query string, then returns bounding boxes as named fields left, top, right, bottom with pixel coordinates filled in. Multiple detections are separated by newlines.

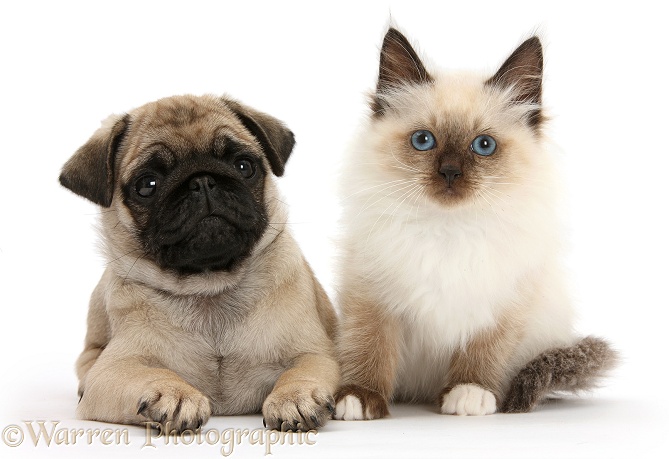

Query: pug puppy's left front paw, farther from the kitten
left=137, top=380, right=211, bottom=432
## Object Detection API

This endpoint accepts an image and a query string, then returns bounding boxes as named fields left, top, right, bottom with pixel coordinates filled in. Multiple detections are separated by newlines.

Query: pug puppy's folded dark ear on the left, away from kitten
left=59, top=115, right=130, bottom=207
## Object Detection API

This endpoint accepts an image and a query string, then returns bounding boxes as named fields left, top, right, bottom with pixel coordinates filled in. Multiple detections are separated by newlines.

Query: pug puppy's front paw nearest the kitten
left=262, top=383, right=334, bottom=431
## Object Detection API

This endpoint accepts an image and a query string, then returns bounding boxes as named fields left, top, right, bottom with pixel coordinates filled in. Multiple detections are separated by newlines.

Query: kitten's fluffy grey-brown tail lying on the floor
left=500, top=336, right=618, bottom=413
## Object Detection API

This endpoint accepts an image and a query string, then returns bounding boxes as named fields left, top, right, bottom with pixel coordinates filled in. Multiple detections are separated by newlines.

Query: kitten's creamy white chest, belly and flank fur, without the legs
left=345, top=178, right=571, bottom=400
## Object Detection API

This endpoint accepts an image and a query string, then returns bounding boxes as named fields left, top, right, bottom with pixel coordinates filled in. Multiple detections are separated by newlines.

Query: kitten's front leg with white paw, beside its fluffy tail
left=439, top=321, right=518, bottom=416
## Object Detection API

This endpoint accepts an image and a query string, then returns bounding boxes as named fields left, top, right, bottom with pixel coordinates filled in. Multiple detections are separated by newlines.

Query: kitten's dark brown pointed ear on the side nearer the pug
left=372, top=27, right=432, bottom=115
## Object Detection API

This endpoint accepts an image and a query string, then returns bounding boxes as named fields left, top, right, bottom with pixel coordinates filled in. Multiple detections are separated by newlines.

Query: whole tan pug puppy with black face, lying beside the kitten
left=60, top=96, right=339, bottom=431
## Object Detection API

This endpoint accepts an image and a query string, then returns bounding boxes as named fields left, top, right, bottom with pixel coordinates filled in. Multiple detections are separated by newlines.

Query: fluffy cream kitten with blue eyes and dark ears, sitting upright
left=335, top=28, right=616, bottom=420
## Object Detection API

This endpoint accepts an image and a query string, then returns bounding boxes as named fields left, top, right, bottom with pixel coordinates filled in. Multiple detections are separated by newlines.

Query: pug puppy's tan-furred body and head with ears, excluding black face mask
left=61, top=96, right=339, bottom=430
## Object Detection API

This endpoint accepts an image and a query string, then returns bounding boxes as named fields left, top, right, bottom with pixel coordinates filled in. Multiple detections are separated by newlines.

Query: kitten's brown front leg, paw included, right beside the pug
left=334, top=300, right=400, bottom=421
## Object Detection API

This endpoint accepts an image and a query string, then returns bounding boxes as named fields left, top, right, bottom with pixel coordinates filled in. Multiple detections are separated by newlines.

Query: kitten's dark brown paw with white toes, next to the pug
left=334, top=385, right=389, bottom=421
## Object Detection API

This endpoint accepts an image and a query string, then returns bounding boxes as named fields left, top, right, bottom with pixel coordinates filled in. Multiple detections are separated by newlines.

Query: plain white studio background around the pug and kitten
left=0, top=0, right=669, bottom=458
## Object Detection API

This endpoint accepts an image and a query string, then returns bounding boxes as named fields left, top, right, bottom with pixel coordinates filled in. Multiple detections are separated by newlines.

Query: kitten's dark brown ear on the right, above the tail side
left=486, top=37, right=544, bottom=127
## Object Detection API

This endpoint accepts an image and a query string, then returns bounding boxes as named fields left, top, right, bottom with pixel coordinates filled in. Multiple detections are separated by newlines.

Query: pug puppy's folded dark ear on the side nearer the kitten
left=223, top=99, right=295, bottom=176
